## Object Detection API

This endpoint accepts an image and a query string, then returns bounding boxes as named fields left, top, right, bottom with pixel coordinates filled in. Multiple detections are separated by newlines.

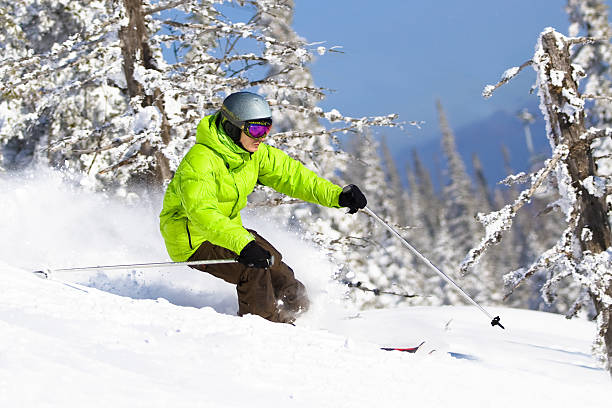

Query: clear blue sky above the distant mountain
left=294, top=0, right=588, bottom=146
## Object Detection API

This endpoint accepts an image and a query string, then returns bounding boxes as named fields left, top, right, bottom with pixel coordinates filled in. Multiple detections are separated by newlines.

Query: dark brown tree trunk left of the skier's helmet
left=119, top=0, right=172, bottom=186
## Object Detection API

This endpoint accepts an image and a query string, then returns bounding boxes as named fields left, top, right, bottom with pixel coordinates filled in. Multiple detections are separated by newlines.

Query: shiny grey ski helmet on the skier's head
left=221, top=92, right=272, bottom=129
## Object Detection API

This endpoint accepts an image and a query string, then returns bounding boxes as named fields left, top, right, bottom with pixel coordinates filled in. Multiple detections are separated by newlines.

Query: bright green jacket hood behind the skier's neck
left=196, top=112, right=251, bottom=170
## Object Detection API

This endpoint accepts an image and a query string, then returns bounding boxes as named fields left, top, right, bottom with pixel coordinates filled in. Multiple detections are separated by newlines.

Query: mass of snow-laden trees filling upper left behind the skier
left=0, top=0, right=395, bottom=192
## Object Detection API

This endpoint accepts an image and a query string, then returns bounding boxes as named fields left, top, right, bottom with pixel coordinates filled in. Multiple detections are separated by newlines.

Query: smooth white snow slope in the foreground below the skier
left=0, top=265, right=610, bottom=407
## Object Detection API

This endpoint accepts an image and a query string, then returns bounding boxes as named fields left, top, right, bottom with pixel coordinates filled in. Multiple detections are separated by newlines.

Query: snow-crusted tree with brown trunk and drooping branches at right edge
left=474, top=28, right=612, bottom=374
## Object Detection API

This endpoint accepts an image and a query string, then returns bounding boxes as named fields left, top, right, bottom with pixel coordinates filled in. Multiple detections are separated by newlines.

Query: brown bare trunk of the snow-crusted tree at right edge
left=540, top=31, right=612, bottom=375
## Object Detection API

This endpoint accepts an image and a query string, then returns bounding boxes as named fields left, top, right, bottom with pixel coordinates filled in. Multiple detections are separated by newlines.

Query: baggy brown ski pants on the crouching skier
left=189, top=230, right=309, bottom=323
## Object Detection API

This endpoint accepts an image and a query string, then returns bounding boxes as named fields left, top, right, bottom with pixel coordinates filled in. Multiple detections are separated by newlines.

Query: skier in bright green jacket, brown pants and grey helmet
left=160, top=92, right=367, bottom=323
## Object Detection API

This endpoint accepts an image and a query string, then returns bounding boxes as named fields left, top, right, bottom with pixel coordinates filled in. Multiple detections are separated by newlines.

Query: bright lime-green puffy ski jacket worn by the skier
left=159, top=113, right=342, bottom=262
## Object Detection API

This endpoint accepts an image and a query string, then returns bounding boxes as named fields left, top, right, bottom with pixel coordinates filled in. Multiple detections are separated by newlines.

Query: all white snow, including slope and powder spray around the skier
left=0, top=169, right=610, bottom=407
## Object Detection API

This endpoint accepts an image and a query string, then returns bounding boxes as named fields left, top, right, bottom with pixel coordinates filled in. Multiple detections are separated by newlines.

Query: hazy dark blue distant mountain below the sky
left=396, top=106, right=550, bottom=187
